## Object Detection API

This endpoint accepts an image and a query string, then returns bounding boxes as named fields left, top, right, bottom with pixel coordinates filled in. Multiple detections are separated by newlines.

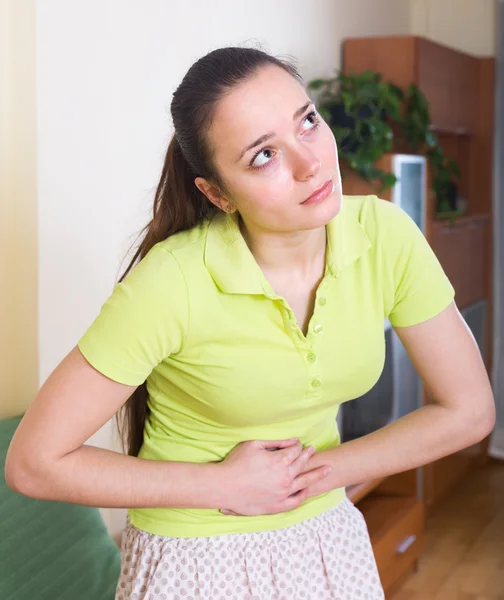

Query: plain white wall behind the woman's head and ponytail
left=37, top=0, right=410, bottom=533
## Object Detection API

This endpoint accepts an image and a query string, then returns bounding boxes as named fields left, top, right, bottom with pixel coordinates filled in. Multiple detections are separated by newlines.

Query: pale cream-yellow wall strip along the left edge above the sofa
left=0, top=0, right=38, bottom=418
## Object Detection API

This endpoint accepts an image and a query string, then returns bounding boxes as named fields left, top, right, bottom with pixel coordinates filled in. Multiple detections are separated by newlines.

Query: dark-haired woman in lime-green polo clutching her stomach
left=6, top=48, right=494, bottom=600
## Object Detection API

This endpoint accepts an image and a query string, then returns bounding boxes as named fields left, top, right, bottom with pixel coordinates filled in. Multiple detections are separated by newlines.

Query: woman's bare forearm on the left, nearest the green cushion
left=6, top=445, right=226, bottom=508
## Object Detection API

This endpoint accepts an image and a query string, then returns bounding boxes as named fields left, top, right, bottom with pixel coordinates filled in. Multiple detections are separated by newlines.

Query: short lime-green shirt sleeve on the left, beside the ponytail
left=78, top=245, right=188, bottom=385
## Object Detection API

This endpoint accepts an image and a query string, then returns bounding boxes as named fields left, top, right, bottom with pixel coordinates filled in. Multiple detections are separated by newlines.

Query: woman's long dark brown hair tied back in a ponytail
left=117, top=47, right=303, bottom=456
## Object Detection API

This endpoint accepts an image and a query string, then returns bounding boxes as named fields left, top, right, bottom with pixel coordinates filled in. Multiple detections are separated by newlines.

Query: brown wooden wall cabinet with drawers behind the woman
left=343, top=36, right=495, bottom=597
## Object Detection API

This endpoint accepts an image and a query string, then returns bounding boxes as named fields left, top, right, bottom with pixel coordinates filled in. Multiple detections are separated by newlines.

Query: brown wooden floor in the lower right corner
left=391, top=461, right=504, bottom=600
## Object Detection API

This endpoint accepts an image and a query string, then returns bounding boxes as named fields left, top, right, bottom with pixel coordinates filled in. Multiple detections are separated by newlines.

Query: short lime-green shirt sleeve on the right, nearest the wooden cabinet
left=378, top=200, right=455, bottom=327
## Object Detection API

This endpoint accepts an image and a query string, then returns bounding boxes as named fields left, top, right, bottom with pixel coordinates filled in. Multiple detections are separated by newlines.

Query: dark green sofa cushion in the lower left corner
left=0, top=416, right=120, bottom=600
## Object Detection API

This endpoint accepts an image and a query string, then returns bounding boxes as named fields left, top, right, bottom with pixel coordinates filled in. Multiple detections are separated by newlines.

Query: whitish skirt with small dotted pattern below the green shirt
left=115, top=498, right=384, bottom=600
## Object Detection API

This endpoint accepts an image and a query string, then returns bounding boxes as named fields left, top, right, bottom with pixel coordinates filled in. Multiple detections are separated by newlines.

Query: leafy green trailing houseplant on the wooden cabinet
left=308, top=71, right=460, bottom=215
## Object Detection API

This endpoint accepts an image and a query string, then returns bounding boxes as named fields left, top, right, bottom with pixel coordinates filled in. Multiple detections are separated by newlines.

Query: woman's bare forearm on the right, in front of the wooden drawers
left=309, top=404, right=489, bottom=496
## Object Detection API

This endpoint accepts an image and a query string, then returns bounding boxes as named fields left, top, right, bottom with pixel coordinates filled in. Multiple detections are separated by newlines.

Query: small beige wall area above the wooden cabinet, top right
left=410, top=0, right=496, bottom=56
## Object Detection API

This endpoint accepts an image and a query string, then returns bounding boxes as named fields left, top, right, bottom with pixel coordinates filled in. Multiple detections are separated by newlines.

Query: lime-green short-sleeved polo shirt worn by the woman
left=79, top=196, right=454, bottom=537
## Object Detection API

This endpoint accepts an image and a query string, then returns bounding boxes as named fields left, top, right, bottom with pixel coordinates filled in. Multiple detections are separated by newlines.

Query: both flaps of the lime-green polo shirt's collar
left=205, top=197, right=371, bottom=295
